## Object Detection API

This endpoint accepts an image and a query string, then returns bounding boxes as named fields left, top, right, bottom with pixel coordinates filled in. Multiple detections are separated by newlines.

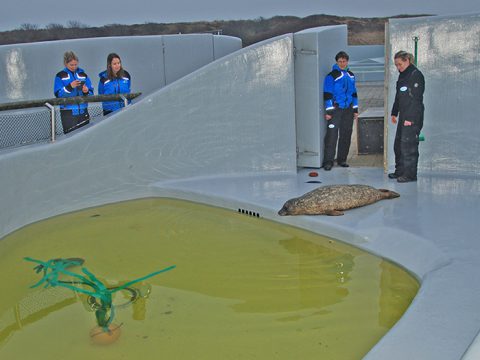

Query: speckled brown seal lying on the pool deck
left=278, top=185, right=400, bottom=216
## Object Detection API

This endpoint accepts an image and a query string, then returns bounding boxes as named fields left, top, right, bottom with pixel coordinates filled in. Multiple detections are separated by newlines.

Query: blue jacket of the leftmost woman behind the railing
left=53, top=68, right=93, bottom=115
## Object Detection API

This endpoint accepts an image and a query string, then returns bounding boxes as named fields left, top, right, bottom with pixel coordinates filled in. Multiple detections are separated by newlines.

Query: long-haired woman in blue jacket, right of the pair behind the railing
left=98, top=53, right=131, bottom=115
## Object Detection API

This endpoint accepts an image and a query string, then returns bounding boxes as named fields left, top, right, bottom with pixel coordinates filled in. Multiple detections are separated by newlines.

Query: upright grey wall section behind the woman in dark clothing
left=386, top=14, right=480, bottom=176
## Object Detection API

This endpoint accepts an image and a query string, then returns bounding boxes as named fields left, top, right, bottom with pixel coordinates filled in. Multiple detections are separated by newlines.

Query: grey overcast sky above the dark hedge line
left=0, top=0, right=480, bottom=31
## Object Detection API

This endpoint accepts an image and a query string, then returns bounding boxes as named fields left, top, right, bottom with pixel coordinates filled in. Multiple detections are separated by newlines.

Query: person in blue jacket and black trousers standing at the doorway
left=323, top=51, right=358, bottom=171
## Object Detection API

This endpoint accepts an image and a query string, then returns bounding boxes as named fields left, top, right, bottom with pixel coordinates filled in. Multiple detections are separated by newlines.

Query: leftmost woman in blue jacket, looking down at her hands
left=53, top=51, right=93, bottom=134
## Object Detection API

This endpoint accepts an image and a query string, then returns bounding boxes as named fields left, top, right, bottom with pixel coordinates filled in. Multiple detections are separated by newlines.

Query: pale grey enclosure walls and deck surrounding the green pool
left=0, top=19, right=480, bottom=360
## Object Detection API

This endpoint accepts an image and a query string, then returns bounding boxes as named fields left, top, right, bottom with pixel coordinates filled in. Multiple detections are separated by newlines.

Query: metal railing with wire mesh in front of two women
left=0, top=93, right=141, bottom=150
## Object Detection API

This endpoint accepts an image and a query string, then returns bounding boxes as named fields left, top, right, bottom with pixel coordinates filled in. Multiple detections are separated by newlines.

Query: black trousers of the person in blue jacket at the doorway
left=323, top=107, right=353, bottom=165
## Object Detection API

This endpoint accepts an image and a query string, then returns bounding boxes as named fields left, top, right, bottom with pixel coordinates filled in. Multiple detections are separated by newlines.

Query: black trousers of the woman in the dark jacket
left=393, top=120, right=422, bottom=179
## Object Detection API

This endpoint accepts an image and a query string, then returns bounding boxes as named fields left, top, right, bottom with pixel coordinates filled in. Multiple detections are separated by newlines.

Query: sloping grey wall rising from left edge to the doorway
left=0, top=35, right=296, bottom=237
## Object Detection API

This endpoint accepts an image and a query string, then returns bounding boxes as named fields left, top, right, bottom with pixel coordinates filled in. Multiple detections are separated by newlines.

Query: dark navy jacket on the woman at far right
left=392, top=64, right=425, bottom=128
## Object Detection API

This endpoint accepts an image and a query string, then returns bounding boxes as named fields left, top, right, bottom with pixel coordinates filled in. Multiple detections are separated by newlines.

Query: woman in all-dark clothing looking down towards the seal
left=388, top=51, right=425, bottom=183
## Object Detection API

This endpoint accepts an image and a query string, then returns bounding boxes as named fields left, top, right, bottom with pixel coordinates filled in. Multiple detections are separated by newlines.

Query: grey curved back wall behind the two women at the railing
left=0, top=34, right=242, bottom=103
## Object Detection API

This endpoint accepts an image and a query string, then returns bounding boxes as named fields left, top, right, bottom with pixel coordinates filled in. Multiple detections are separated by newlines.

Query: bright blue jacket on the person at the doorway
left=323, top=64, right=358, bottom=115
